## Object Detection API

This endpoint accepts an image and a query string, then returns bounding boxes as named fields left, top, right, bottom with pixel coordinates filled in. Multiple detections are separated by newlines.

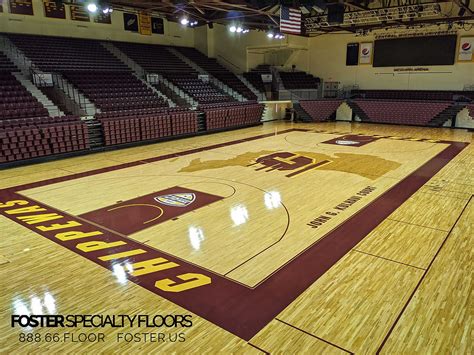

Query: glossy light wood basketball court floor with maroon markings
left=0, top=122, right=474, bottom=354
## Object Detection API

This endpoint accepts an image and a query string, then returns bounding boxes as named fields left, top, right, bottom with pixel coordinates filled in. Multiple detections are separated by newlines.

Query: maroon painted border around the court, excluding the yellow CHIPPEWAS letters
left=0, top=129, right=468, bottom=341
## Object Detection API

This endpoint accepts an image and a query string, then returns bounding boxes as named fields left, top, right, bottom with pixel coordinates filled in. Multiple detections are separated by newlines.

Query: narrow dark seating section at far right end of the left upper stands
left=176, top=47, right=257, bottom=100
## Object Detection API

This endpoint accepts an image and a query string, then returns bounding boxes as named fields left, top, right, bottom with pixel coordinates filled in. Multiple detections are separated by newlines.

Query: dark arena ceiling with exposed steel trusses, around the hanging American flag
left=107, top=0, right=474, bottom=35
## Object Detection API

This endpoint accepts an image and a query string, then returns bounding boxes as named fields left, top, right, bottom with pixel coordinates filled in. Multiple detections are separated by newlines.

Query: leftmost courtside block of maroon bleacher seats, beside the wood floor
left=0, top=116, right=89, bottom=163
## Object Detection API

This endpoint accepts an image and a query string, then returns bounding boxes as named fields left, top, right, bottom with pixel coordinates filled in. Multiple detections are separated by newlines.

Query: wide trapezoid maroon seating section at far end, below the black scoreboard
left=355, top=100, right=452, bottom=125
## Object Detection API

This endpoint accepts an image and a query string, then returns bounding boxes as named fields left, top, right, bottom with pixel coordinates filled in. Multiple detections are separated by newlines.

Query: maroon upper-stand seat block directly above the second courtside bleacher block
left=63, top=71, right=168, bottom=111
